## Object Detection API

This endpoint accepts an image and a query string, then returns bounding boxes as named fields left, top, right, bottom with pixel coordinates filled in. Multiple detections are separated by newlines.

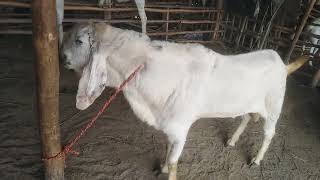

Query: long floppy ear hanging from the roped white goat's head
left=76, top=53, right=107, bottom=110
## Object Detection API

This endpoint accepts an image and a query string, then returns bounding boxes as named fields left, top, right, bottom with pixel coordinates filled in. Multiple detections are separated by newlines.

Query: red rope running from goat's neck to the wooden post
left=42, top=64, right=144, bottom=160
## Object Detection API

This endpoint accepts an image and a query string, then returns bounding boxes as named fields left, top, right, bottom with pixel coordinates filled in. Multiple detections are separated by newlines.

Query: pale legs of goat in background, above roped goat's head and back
left=56, top=0, right=147, bottom=45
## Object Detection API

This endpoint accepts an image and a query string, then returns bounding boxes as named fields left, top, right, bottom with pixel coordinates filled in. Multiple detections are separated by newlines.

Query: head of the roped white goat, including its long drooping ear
left=61, top=23, right=107, bottom=110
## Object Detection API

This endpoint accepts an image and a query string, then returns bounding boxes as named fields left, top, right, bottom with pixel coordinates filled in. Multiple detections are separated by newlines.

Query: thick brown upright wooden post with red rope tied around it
left=32, top=0, right=64, bottom=180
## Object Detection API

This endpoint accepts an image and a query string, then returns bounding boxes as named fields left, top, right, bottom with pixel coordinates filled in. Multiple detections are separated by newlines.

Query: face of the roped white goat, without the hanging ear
left=61, top=23, right=97, bottom=73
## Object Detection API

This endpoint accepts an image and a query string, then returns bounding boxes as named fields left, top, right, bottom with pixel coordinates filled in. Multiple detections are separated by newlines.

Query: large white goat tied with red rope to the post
left=63, top=23, right=306, bottom=180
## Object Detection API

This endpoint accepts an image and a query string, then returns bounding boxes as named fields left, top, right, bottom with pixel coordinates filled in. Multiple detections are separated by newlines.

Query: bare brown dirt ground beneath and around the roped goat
left=0, top=36, right=320, bottom=180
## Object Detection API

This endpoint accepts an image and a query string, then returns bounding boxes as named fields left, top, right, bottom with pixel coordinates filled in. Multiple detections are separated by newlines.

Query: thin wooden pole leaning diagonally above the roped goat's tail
left=285, top=0, right=317, bottom=64
